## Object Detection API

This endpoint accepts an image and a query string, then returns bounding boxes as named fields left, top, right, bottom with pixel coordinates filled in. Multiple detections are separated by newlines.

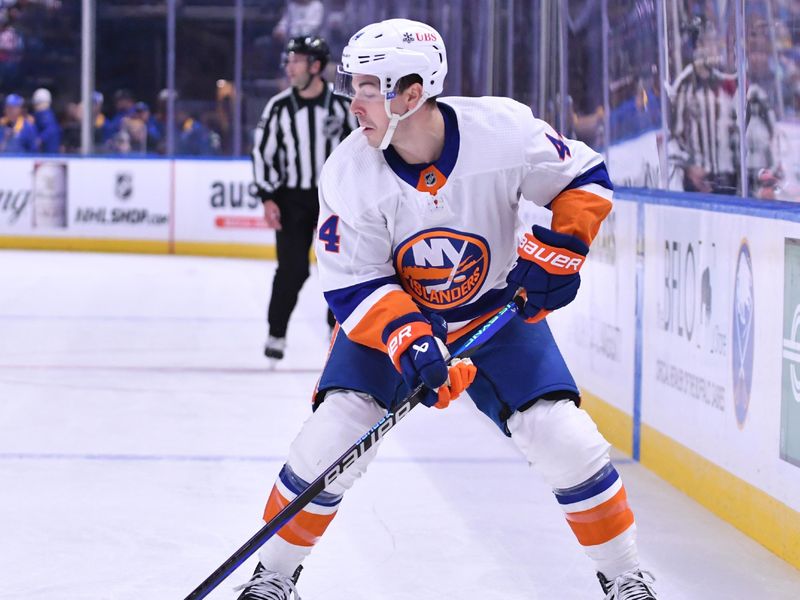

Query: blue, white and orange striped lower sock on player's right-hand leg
left=553, top=462, right=639, bottom=578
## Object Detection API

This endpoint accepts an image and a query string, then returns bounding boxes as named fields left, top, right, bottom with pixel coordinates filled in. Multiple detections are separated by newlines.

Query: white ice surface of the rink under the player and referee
left=0, top=251, right=800, bottom=600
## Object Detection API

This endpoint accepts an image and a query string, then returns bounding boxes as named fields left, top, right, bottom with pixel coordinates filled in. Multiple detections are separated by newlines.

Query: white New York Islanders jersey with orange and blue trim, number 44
left=315, top=97, right=612, bottom=350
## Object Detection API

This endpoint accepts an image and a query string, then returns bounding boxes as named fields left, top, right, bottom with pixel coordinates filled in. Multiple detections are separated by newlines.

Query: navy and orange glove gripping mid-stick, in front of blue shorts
left=384, top=313, right=477, bottom=408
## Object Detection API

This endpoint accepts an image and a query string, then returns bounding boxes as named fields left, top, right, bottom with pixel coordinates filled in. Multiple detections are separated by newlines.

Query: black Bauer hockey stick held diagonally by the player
left=186, top=296, right=523, bottom=600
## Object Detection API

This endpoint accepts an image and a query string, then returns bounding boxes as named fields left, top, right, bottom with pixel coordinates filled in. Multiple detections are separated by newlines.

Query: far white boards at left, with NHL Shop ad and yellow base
left=0, top=157, right=275, bottom=258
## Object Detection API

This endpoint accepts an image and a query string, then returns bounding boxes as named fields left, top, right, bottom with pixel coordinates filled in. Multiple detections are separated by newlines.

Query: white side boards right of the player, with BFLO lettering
left=549, top=189, right=800, bottom=567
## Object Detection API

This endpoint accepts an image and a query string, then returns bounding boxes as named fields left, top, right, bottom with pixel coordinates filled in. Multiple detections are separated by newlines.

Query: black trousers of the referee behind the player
left=267, top=189, right=336, bottom=338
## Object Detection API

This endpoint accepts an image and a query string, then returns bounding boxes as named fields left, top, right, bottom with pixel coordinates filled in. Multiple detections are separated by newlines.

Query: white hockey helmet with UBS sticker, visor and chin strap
left=334, top=19, right=447, bottom=149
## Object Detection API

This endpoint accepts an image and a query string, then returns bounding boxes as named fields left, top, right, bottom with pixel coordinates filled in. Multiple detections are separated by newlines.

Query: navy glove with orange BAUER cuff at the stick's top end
left=506, top=225, right=589, bottom=323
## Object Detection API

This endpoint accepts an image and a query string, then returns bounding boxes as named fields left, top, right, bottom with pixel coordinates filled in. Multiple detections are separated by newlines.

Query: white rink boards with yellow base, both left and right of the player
left=0, top=157, right=800, bottom=567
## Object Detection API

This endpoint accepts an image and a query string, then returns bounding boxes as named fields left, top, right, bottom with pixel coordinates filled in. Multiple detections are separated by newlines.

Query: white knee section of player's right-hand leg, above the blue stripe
left=508, top=400, right=611, bottom=488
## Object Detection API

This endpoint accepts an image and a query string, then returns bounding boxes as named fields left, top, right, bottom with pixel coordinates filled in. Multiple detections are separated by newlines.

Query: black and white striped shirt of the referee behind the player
left=253, top=83, right=358, bottom=199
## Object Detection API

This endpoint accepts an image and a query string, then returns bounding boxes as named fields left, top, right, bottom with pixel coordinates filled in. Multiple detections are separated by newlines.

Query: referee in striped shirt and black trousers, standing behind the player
left=253, top=36, right=357, bottom=359
